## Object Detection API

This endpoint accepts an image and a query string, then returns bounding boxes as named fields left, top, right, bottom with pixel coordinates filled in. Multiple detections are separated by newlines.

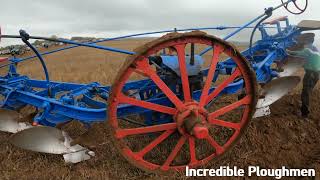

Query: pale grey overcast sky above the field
left=0, top=0, right=320, bottom=46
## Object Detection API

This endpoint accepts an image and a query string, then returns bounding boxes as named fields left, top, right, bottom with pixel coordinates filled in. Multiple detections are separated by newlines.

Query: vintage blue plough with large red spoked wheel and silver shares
left=0, top=0, right=320, bottom=172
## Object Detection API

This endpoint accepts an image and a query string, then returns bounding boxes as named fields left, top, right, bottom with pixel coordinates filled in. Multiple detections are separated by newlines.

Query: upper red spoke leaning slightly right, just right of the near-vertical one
left=199, top=45, right=222, bottom=107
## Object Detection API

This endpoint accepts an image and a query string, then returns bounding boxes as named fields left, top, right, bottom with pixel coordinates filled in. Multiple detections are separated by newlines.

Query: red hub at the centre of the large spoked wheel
left=174, top=102, right=209, bottom=139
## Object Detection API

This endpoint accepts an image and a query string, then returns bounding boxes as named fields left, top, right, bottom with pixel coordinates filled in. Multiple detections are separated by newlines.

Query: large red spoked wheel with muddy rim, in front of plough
left=108, top=31, right=257, bottom=172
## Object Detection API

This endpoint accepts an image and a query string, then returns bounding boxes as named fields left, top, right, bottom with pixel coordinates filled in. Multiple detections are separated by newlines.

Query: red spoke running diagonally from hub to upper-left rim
left=137, top=58, right=184, bottom=110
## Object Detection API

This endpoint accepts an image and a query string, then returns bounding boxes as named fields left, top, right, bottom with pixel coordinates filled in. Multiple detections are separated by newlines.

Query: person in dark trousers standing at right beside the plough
left=287, top=33, right=320, bottom=119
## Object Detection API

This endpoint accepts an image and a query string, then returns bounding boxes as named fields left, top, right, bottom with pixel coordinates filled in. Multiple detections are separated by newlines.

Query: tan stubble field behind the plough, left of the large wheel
left=18, top=38, right=152, bottom=84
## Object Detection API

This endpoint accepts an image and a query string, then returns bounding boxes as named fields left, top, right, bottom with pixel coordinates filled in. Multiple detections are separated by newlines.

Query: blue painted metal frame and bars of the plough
left=0, top=0, right=300, bottom=126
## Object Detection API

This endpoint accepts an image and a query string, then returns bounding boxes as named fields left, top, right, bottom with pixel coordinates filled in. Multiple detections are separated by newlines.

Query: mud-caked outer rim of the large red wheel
left=108, top=33, right=257, bottom=172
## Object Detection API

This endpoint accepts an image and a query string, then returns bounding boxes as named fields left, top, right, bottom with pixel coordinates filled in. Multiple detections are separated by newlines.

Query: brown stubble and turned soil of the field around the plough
left=0, top=38, right=320, bottom=179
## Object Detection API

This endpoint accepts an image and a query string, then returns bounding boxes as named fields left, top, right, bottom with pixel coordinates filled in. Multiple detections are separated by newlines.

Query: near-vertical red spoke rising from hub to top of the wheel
left=174, top=44, right=191, bottom=102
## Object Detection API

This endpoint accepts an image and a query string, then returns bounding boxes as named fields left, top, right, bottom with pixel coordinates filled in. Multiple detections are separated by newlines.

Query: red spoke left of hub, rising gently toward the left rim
left=118, top=95, right=176, bottom=115
